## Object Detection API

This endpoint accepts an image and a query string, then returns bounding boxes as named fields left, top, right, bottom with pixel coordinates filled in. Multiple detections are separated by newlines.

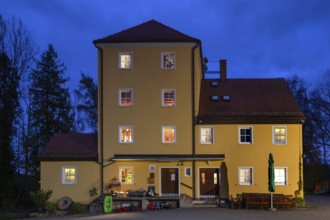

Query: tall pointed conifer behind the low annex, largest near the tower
left=29, top=45, right=73, bottom=175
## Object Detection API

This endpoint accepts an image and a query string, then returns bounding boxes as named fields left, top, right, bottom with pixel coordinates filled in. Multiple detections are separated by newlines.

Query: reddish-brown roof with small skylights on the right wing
left=198, top=78, right=304, bottom=124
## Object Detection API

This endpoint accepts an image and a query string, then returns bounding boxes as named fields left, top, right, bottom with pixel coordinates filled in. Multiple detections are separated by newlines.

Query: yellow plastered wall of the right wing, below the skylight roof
left=196, top=124, right=302, bottom=195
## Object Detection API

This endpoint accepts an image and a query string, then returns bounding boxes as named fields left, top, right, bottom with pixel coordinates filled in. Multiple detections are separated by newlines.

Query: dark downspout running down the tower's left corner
left=94, top=42, right=104, bottom=196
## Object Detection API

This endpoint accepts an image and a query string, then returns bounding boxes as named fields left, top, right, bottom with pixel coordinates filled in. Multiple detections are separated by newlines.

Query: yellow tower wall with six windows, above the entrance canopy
left=103, top=44, right=201, bottom=159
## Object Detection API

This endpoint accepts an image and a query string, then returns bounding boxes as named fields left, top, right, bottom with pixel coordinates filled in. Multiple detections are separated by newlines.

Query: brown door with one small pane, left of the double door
left=160, top=168, right=179, bottom=196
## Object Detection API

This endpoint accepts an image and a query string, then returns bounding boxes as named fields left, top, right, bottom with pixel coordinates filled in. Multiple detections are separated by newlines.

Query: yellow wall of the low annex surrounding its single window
left=40, top=161, right=101, bottom=204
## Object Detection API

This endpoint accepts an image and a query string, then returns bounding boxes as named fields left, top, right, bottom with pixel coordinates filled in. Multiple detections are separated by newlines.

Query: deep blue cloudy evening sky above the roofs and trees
left=0, top=0, right=330, bottom=88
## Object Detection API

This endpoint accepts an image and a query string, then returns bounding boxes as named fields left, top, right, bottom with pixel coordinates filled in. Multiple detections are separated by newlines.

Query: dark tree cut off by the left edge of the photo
left=0, top=52, right=19, bottom=208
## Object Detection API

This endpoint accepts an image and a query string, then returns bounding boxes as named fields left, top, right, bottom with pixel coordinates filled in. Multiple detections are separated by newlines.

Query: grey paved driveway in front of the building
left=29, top=195, right=330, bottom=220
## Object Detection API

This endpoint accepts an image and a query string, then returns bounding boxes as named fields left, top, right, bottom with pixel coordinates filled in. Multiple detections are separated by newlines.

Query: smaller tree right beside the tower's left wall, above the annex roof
left=74, top=73, right=97, bottom=132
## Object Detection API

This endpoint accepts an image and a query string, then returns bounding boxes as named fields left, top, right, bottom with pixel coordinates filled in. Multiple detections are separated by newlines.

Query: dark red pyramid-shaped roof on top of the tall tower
left=94, top=20, right=200, bottom=44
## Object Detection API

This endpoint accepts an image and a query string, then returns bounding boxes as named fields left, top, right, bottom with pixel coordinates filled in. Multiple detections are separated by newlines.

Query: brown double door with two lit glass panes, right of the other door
left=199, top=168, right=220, bottom=197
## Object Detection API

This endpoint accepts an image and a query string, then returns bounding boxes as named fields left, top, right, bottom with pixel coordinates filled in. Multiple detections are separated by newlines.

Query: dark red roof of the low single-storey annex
left=39, top=133, right=98, bottom=161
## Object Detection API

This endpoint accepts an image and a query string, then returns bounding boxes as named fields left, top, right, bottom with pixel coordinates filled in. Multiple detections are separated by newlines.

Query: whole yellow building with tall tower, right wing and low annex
left=41, top=20, right=304, bottom=205
